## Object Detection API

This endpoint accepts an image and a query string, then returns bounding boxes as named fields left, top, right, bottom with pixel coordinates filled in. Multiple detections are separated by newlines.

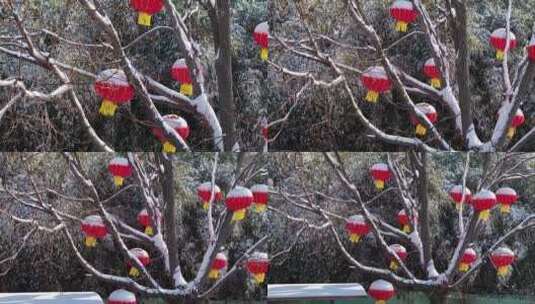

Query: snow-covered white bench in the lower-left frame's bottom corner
left=0, top=292, right=104, bottom=304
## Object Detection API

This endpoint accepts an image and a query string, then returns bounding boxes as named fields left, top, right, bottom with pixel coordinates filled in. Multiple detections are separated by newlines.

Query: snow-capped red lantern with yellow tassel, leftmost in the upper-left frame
left=95, top=69, right=134, bottom=117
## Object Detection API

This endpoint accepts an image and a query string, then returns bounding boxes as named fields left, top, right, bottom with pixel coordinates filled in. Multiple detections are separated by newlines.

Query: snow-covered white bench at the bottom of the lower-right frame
left=267, top=283, right=367, bottom=302
